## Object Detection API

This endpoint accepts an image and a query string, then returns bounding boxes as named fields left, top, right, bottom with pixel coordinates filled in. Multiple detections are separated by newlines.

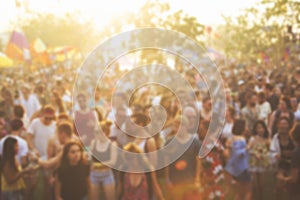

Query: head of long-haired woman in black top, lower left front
left=61, top=141, right=84, bottom=166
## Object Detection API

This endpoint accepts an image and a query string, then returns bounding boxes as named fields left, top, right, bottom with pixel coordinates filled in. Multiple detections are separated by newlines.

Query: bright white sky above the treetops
left=0, top=0, right=258, bottom=32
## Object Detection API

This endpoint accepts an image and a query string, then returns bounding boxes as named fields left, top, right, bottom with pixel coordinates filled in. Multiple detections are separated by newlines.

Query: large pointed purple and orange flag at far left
left=5, top=31, right=30, bottom=61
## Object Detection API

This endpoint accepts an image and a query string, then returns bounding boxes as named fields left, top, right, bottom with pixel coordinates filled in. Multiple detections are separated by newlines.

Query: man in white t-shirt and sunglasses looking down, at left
left=27, top=105, right=56, bottom=159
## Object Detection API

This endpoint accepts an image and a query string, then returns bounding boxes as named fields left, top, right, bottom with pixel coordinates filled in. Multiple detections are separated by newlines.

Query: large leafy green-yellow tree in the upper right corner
left=215, top=0, right=300, bottom=63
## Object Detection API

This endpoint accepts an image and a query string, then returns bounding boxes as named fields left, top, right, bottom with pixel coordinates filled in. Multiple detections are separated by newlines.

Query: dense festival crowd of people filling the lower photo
left=0, top=57, right=300, bottom=200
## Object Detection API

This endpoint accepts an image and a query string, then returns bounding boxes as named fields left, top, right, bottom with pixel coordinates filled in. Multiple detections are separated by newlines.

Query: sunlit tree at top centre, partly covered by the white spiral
left=100, top=1, right=204, bottom=63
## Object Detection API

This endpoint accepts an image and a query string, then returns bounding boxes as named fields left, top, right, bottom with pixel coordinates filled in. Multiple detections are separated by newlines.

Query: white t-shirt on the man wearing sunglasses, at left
left=28, top=118, right=56, bottom=159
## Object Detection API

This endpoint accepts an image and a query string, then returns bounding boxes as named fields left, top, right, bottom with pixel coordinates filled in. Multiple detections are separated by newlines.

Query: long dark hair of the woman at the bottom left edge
left=1, top=137, right=18, bottom=171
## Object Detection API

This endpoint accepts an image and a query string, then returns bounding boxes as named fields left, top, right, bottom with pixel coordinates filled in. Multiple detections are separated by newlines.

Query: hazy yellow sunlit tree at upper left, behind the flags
left=21, top=13, right=96, bottom=51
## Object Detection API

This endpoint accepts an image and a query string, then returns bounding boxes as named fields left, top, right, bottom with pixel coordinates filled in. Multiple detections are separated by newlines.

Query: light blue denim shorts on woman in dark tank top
left=90, top=170, right=115, bottom=185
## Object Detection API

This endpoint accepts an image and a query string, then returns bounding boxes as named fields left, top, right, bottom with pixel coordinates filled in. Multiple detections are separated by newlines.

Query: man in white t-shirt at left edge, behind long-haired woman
left=0, top=119, right=28, bottom=166
